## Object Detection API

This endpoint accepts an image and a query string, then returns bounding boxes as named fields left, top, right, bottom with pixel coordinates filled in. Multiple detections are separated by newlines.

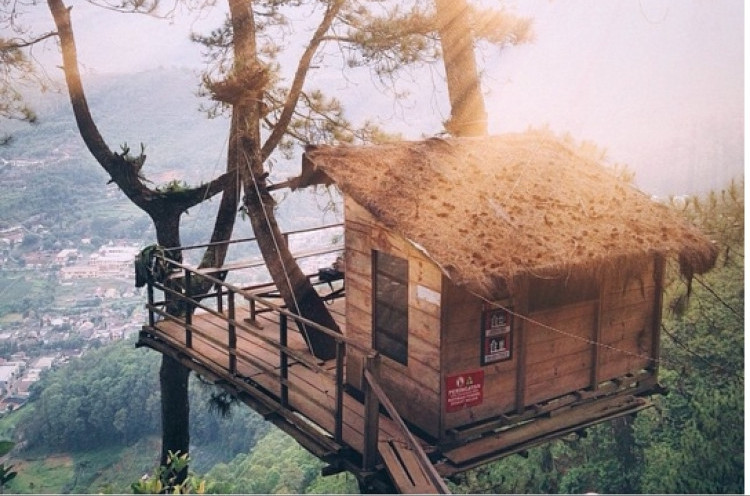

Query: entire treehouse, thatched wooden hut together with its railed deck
left=140, top=133, right=716, bottom=492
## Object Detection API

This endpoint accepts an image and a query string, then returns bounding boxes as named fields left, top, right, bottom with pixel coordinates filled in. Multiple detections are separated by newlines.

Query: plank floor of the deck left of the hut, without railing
left=139, top=280, right=447, bottom=494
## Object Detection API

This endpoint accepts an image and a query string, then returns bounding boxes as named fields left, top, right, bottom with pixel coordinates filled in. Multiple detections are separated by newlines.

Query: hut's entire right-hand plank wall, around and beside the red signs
left=442, top=259, right=660, bottom=429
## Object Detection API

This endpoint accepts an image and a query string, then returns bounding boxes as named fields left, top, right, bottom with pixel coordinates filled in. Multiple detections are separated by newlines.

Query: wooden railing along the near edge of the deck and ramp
left=141, top=230, right=448, bottom=493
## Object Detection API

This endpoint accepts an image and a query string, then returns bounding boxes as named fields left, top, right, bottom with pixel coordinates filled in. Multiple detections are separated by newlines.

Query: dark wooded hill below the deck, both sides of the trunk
left=16, top=340, right=269, bottom=462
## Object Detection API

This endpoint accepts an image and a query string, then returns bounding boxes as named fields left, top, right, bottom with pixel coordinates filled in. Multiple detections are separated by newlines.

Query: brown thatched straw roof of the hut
left=303, top=132, right=716, bottom=297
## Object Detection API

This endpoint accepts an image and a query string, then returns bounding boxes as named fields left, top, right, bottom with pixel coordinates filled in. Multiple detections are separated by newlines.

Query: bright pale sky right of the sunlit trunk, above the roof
left=487, top=0, right=744, bottom=198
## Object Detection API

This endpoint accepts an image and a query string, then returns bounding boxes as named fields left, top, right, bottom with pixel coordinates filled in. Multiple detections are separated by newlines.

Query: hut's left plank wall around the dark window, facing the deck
left=345, top=198, right=442, bottom=436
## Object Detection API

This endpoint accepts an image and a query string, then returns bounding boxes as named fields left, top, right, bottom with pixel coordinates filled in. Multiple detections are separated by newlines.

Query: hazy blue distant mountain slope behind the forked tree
left=0, top=68, right=340, bottom=244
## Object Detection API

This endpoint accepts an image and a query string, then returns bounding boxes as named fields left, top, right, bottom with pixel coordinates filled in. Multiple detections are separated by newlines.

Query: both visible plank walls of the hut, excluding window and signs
left=345, top=194, right=661, bottom=438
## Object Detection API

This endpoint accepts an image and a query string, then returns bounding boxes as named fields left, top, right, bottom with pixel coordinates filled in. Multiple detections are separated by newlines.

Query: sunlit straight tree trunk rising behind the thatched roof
left=435, top=0, right=487, bottom=136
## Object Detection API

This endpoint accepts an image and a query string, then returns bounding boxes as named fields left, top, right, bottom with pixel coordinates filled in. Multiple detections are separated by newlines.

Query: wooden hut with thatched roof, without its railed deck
left=296, top=133, right=716, bottom=458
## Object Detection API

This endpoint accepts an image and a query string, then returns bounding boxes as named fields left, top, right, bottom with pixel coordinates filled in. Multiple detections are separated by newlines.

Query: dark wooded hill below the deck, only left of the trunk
left=18, top=341, right=160, bottom=451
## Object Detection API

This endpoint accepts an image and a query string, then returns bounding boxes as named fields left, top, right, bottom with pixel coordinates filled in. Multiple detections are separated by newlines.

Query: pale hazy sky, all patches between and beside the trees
left=30, top=0, right=744, bottom=195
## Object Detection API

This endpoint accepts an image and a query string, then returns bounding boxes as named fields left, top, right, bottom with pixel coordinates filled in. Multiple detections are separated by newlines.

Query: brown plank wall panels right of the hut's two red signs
left=525, top=259, right=660, bottom=406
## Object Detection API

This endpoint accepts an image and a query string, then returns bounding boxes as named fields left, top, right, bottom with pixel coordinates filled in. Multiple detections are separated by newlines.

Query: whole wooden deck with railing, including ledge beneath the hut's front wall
left=138, top=242, right=654, bottom=493
